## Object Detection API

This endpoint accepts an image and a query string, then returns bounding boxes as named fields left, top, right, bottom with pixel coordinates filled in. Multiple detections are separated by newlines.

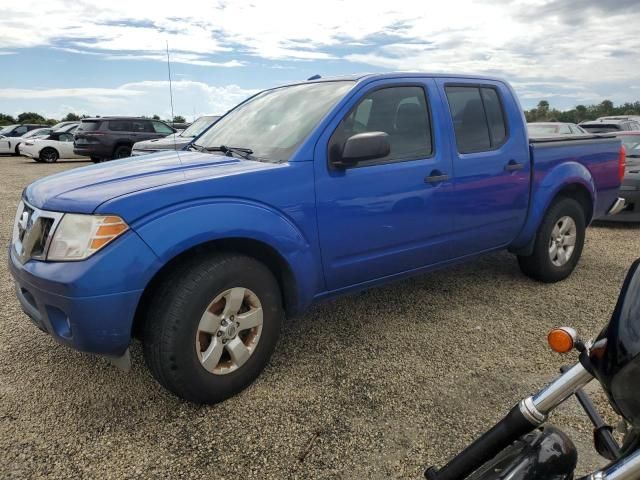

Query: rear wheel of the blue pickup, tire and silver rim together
left=518, top=198, right=586, bottom=283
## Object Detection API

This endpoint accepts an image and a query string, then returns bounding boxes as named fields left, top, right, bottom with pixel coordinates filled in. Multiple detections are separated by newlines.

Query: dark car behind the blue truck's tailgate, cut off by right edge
left=605, top=131, right=640, bottom=222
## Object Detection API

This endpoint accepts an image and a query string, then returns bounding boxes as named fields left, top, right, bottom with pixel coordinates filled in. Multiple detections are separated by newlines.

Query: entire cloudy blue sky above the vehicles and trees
left=0, top=0, right=640, bottom=120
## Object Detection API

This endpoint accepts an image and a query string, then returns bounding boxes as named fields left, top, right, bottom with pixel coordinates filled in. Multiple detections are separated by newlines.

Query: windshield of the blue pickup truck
left=196, top=81, right=354, bottom=162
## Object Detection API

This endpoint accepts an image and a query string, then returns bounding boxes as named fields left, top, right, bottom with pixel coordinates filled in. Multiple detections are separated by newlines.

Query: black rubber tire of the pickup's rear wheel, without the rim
left=518, top=197, right=586, bottom=283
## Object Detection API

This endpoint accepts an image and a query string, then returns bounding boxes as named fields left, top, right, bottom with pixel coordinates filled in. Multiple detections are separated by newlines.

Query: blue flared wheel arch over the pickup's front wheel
left=132, top=199, right=322, bottom=309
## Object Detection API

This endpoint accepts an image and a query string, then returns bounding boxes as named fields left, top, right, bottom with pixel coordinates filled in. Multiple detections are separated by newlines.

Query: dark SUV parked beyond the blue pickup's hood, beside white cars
left=73, top=117, right=176, bottom=162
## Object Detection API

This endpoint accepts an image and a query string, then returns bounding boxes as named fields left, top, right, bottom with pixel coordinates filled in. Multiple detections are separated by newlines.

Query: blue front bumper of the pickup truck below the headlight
left=9, top=232, right=157, bottom=357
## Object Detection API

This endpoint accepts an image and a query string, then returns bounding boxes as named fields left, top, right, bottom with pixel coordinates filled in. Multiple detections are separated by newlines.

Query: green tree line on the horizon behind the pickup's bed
left=524, top=100, right=640, bottom=123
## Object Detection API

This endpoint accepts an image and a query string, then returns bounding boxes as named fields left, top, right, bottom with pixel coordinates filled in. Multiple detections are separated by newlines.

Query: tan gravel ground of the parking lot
left=0, top=157, right=640, bottom=479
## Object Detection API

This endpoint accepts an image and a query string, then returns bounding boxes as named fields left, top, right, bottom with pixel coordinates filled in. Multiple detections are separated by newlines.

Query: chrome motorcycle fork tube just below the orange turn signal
left=520, top=363, right=593, bottom=424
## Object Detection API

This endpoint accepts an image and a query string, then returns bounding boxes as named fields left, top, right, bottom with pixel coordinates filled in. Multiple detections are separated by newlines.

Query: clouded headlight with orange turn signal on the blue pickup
left=47, top=213, right=129, bottom=261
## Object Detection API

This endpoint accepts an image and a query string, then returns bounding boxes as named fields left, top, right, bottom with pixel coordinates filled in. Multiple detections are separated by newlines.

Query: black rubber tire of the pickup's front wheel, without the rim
left=142, top=254, right=284, bottom=403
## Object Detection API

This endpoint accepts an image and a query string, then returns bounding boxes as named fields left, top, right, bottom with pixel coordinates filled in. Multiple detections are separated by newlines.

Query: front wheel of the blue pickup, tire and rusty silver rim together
left=143, top=254, right=284, bottom=403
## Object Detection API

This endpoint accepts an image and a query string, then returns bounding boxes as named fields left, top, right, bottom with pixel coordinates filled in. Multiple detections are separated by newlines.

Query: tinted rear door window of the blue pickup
left=445, top=86, right=507, bottom=153
